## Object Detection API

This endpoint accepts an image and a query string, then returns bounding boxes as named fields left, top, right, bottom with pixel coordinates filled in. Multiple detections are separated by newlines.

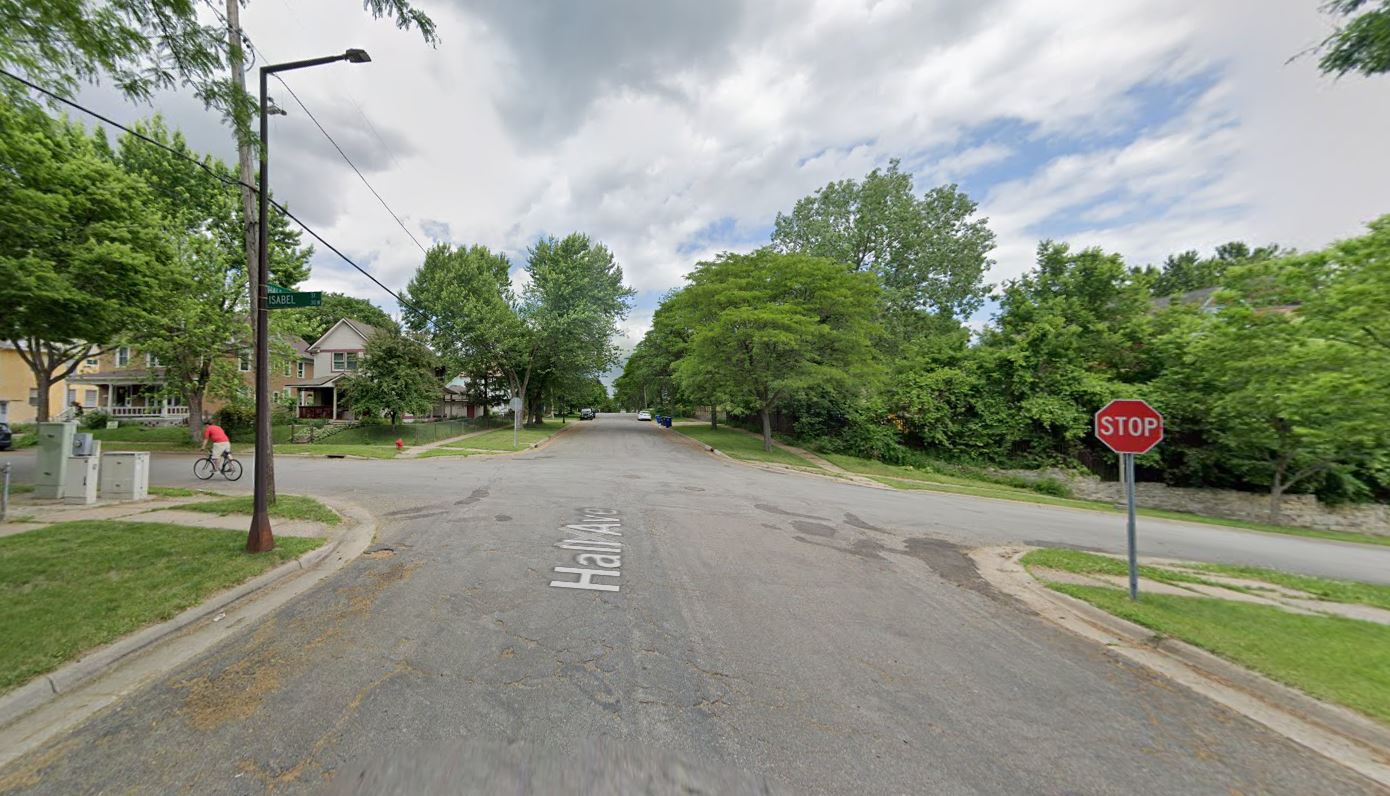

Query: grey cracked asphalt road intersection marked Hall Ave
left=0, top=415, right=1390, bottom=795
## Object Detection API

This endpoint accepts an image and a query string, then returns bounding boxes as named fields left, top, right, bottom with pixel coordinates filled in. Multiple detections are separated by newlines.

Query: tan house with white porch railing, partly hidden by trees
left=67, top=338, right=313, bottom=424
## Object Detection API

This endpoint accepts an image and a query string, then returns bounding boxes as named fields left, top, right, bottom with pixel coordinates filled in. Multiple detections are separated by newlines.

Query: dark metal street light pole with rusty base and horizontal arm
left=246, top=49, right=371, bottom=553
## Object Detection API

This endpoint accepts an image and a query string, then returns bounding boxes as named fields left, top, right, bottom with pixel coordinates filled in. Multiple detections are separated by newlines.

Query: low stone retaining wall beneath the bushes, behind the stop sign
left=999, top=470, right=1390, bottom=536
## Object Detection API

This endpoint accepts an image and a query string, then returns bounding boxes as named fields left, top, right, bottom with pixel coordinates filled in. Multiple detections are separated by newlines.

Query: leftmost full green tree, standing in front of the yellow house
left=0, top=101, right=170, bottom=421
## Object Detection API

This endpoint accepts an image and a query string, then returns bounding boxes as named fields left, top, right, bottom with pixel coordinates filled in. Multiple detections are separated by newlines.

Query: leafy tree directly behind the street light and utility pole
left=118, top=117, right=313, bottom=440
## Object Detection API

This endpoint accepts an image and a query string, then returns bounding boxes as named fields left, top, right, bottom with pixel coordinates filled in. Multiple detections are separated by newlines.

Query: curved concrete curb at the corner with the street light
left=0, top=500, right=375, bottom=733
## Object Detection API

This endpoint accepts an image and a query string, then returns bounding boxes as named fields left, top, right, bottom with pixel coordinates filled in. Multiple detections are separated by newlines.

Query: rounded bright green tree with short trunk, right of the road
left=674, top=249, right=878, bottom=450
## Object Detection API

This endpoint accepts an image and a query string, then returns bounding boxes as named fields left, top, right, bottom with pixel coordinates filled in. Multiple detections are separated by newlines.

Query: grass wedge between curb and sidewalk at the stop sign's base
left=1051, top=583, right=1390, bottom=722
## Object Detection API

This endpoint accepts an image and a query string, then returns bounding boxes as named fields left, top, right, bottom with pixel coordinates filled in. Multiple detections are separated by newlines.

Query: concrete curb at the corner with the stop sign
left=970, top=547, right=1390, bottom=788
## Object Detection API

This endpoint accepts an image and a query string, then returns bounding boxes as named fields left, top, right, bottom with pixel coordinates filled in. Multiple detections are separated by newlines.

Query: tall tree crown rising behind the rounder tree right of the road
left=773, top=160, right=994, bottom=323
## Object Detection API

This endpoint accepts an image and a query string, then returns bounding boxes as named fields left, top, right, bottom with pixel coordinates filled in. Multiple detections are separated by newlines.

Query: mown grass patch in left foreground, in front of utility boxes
left=0, top=521, right=324, bottom=692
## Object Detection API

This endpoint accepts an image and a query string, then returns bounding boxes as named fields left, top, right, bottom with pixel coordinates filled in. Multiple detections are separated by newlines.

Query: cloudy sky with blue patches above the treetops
left=73, top=0, right=1390, bottom=342
